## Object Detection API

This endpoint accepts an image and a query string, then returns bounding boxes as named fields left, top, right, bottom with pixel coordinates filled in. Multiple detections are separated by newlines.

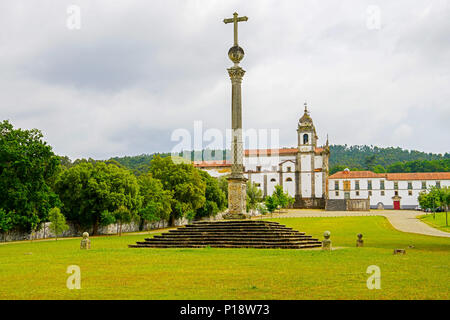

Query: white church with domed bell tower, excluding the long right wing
left=194, top=104, right=330, bottom=208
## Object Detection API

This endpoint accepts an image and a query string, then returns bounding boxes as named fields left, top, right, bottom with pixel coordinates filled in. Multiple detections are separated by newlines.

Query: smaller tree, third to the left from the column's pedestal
left=138, top=173, right=173, bottom=229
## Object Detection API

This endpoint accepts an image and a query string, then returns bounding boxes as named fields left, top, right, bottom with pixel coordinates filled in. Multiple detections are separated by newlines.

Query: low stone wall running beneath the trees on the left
left=0, top=213, right=223, bottom=241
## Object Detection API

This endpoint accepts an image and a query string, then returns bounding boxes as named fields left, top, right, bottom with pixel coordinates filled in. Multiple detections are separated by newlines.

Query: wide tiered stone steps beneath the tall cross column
left=129, top=220, right=322, bottom=249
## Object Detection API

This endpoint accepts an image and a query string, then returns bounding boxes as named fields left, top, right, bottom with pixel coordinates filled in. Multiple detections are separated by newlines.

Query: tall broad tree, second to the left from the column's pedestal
left=150, top=156, right=206, bottom=226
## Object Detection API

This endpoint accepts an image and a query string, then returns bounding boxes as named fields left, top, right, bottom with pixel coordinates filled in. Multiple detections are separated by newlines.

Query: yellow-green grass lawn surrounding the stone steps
left=0, top=216, right=450, bottom=299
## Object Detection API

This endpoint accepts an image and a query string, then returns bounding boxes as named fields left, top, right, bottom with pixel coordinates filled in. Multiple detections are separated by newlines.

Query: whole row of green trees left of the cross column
left=0, top=121, right=227, bottom=234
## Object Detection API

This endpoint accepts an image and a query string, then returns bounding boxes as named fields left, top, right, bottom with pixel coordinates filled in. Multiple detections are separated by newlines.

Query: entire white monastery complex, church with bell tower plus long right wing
left=194, top=103, right=450, bottom=210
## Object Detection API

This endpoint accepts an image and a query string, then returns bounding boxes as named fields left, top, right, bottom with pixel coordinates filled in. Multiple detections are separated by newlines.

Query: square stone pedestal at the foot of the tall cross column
left=224, top=177, right=247, bottom=219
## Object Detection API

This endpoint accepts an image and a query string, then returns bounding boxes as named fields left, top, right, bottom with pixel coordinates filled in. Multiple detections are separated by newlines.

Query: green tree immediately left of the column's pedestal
left=195, top=170, right=227, bottom=217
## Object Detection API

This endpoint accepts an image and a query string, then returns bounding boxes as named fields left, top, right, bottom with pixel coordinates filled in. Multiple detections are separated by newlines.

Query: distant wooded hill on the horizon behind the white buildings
left=111, top=145, right=450, bottom=174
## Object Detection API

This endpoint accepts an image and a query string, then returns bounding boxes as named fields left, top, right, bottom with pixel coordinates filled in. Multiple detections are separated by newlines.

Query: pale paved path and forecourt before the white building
left=253, top=209, right=450, bottom=238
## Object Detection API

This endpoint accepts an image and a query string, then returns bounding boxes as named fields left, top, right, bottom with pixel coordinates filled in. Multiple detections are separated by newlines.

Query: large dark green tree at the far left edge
left=0, top=121, right=60, bottom=232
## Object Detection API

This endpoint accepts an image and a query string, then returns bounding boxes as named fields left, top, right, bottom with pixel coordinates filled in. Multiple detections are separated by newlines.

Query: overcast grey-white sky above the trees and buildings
left=0, top=0, right=450, bottom=159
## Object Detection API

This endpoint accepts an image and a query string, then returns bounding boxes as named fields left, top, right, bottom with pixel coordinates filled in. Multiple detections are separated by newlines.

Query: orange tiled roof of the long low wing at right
left=328, top=171, right=450, bottom=181
